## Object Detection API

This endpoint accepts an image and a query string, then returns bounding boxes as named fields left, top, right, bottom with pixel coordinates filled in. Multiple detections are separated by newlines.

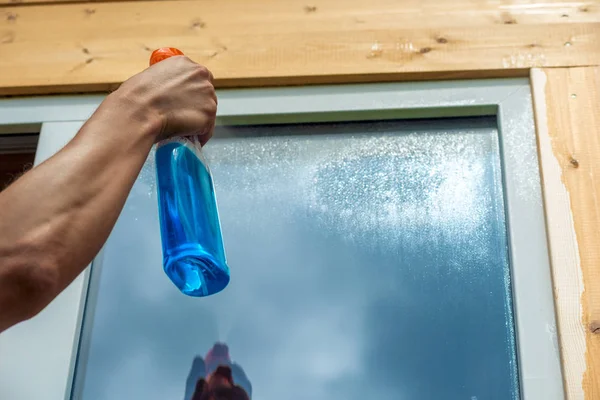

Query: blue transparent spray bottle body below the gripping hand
left=156, top=138, right=229, bottom=297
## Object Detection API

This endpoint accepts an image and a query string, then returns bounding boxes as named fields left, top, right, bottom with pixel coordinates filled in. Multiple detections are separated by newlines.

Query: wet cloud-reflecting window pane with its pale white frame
left=0, top=80, right=562, bottom=400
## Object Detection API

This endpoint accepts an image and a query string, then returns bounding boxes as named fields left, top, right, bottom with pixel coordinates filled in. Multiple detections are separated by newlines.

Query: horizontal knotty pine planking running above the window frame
left=0, top=0, right=600, bottom=95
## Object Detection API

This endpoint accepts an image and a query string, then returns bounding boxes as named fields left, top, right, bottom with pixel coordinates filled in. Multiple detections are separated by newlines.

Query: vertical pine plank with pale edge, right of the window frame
left=532, top=67, right=600, bottom=400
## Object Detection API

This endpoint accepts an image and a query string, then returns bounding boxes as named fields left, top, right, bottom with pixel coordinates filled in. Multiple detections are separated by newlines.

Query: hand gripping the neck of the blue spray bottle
left=111, top=56, right=217, bottom=145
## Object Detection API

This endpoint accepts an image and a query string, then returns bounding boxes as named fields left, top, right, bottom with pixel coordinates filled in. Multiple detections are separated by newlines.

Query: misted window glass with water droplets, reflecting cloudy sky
left=75, top=118, right=519, bottom=400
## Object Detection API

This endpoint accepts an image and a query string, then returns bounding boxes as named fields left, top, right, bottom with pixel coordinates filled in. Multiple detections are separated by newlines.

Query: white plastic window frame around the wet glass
left=0, top=79, right=564, bottom=400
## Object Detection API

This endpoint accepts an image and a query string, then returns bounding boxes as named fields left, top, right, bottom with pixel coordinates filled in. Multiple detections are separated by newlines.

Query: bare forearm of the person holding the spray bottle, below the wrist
left=0, top=95, right=161, bottom=332
